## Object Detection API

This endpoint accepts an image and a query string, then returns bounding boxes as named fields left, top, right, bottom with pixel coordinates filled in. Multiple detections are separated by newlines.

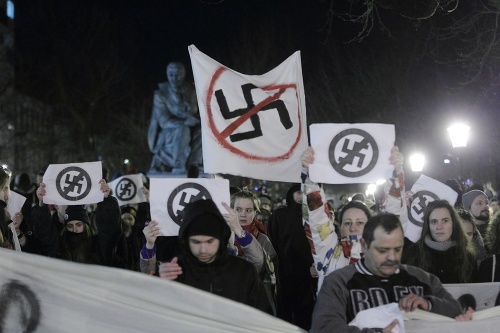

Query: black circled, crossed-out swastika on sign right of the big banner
left=328, top=128, right=379, bottom=178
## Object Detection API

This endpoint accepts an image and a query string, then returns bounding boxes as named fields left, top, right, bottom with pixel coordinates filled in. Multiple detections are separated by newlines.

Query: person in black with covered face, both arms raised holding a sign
left=31, top=179, right=127, bottom=267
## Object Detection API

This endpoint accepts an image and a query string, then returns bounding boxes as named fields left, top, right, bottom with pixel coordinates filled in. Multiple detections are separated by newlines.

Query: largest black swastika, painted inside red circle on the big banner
left=215, top=83, right=293, bottom=142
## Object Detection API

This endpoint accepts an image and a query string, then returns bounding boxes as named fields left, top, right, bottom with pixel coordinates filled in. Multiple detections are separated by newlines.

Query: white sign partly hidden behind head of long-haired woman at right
left=405, top=175, right=458, bottom=243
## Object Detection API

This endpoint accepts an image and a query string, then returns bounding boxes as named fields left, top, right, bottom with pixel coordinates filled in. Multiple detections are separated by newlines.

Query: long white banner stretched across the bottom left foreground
left=0, top=249, right=305, bottom=333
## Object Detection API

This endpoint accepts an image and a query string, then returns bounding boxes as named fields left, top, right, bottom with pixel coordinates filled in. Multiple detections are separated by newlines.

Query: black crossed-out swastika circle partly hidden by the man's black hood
left=167, top=183, right=212, bottom=226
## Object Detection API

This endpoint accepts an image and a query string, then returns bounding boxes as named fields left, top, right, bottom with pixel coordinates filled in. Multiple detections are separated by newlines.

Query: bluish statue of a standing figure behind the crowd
left=148, top=62, right=202, bottom=174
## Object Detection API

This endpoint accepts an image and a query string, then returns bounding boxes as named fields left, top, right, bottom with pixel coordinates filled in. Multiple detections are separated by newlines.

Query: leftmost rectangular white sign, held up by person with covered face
left=43, top=162, right=104, bottom=205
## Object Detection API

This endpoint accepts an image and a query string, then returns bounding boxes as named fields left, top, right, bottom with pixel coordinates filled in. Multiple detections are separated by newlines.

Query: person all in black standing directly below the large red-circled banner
left=269, top=184, right=315, bottom=330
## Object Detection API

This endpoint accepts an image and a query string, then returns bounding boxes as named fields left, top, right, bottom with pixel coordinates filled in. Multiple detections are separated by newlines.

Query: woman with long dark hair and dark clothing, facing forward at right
left=402, top=200, right=477, bottom=283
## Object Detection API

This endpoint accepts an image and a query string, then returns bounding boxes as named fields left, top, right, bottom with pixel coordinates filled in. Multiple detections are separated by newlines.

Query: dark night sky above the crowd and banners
left=9, top=0, right=500, bottom=187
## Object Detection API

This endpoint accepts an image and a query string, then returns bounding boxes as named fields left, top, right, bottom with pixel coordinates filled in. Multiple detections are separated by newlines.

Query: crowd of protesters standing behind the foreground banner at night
left=0, top=147, right=500, bottom=332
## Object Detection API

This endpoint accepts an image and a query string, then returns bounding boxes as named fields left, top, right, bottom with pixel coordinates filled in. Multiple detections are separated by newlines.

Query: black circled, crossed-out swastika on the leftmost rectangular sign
left=56, top=166, right=92, bottom=201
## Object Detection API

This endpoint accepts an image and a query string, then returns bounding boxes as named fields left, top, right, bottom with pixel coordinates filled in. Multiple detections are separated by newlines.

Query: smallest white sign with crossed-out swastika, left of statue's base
left=109, top=174, right=147, bottom=206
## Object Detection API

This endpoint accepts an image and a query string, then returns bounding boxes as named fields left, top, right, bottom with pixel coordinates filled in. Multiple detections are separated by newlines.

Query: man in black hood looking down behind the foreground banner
left=140, top=199, right=271, bottom=313
